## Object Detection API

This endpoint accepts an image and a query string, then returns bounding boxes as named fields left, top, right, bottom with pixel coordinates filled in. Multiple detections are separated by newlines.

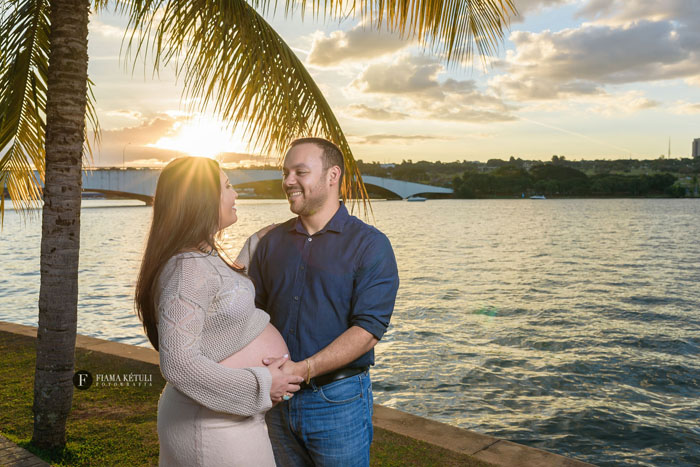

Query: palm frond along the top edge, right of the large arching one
left=250, top=0, right=517, bottom=63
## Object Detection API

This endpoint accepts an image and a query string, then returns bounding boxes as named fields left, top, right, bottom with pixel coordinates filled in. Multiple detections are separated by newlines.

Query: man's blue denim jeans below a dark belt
left=265, top=371, right=374, bottom=467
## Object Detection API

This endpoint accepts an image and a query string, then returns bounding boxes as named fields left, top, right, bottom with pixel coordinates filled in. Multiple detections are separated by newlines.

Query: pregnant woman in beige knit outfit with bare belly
left=135, top=157, right=302, bottom=466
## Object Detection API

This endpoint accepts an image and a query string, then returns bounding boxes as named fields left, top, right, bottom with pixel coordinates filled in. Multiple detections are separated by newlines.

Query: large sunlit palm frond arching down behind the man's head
left=122, top=0, right=368, bottom=209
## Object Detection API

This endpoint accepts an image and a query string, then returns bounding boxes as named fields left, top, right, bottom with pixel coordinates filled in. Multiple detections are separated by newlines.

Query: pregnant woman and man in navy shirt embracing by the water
left=136, top=138, right=399, bottom=467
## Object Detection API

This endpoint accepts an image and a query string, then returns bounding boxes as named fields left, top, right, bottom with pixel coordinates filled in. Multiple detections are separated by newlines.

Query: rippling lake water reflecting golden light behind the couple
left=0, top=200, right=700, bottom=465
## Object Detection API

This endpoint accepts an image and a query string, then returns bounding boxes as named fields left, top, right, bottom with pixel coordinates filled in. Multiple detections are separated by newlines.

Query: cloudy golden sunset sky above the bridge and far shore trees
left=89, top=0, right=700, bottom=166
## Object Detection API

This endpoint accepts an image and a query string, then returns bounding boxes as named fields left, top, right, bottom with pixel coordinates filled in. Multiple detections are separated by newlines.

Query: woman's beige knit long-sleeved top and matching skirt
left=157, top=239, right=275, bottom=467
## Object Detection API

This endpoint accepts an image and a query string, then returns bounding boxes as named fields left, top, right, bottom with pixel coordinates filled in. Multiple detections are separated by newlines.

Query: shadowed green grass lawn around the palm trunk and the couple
left=0, top=331, right=489, bottom=467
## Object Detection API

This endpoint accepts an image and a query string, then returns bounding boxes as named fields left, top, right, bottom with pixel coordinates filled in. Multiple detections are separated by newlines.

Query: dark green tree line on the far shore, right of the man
left=358, top=155, right=700, bottom=198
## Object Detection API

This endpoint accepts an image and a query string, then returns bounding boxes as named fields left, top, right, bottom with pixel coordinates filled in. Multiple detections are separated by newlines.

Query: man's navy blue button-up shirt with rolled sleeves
left=249, top=204, right=399, bottom=367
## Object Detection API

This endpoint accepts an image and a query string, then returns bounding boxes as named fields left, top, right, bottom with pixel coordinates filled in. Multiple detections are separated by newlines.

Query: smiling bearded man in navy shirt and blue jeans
left=249, top=138, right=399, bottom=466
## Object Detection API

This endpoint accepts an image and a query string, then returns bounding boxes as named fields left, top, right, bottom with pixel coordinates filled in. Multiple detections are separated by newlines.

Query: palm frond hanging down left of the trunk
left=0, top=0, right=50, bottom=223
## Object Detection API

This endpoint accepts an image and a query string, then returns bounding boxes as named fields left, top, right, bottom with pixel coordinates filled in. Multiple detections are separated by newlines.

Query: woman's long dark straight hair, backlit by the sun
left=135, top=157, right=221, bottom=350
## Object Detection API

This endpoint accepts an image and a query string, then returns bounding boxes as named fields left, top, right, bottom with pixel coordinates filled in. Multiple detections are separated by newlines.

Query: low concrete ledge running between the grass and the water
left=0, top=321, right=592, bottom=467
